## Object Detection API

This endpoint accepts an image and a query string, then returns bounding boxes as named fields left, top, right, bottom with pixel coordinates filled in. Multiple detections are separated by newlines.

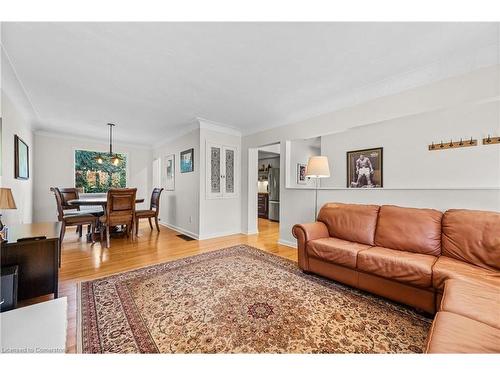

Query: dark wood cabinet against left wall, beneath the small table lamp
left=1, top=222, right=61, bottom=300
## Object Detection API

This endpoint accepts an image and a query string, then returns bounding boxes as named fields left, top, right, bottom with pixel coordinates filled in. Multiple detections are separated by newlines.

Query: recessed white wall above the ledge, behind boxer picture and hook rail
left=321, top=100, right=500, bottom=188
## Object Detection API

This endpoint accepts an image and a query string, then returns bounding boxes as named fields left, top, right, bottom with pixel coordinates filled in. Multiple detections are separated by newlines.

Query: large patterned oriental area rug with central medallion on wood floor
left=78, top=245, right=430, bottom=353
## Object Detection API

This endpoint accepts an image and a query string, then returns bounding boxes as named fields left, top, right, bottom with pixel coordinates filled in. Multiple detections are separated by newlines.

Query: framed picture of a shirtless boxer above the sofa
left=347, top=147, right=384, bottom=188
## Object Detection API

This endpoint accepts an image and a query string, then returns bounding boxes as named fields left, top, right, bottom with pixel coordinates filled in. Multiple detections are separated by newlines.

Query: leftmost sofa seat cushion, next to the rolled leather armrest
left=307, top=237, right=371, bottom=269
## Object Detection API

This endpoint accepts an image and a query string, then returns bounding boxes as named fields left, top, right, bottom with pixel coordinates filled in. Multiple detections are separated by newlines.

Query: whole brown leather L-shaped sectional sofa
left=292, top=203, right=500, bottom=352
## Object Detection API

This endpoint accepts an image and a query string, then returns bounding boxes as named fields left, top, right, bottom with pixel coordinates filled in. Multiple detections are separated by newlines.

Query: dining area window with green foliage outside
left=75, top=150, right=127, bottom=193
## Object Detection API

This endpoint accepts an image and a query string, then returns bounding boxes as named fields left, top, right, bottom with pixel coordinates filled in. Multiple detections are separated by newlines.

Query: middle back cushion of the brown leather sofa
left=375, top=206, right=443, bottom=256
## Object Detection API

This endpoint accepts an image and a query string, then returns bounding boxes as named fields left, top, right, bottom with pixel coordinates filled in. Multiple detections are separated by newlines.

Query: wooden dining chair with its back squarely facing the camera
left=99, top=188, right=137, bottom=248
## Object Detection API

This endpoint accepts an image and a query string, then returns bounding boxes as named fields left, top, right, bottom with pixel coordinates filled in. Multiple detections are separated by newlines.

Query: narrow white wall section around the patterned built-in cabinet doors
left=199, top=122, right=241, bottom=239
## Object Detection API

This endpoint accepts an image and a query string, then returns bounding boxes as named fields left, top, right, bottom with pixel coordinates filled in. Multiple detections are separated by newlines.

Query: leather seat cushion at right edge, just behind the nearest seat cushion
left=441, top=279, right=500, bottom=329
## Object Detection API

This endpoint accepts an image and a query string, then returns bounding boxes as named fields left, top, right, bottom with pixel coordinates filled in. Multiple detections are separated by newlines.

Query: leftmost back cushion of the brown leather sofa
left=318, top=203, right=379, bottom=246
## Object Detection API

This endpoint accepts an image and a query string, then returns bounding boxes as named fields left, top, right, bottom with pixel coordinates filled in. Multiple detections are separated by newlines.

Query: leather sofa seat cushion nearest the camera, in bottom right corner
left=426, top=311, right=500, bottom=353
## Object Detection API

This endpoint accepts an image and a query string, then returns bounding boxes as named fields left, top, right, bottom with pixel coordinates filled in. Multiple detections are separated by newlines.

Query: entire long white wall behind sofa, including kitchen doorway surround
left=242, top=65, right=500, bottom=244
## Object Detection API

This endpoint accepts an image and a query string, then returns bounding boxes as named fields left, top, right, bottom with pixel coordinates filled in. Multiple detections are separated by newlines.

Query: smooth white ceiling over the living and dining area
left=2, top=22, right=499, bottom=145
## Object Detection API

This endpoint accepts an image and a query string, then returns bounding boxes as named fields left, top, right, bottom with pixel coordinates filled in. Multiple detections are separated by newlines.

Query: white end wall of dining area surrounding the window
left=34, top=133, right=152, bottom=222
